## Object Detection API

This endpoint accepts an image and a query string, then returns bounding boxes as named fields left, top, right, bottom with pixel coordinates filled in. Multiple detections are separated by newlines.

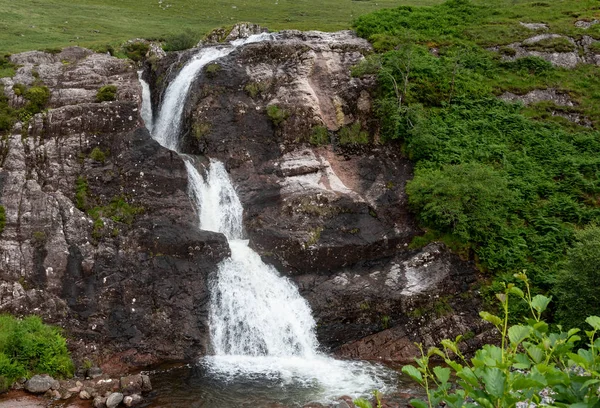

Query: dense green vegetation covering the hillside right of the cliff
left=354, top=0, right=600, bottom=327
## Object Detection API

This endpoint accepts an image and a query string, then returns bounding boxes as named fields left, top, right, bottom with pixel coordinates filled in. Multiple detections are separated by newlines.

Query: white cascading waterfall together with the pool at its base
left=142, top=34, right=396, bottom=407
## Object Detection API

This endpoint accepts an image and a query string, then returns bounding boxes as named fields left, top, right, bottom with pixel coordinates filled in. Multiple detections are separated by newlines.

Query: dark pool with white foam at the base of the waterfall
left=143, top=356, right=423, bottom=408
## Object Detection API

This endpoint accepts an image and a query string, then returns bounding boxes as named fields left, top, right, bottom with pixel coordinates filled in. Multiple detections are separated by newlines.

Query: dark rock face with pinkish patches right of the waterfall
left=148, top=27, right=485, bottom=361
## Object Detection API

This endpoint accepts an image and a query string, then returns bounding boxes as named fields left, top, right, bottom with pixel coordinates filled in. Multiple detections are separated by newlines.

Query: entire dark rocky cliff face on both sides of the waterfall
left=0, top=30, right=481, bottom=370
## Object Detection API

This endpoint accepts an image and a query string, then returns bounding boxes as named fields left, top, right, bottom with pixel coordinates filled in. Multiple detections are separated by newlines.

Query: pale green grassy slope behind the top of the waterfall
left=0, top=0, right=440, bottom=53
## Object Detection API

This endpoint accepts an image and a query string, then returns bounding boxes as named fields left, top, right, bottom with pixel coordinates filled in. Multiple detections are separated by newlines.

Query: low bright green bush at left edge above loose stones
left=0, top=315, right=73, bottom=382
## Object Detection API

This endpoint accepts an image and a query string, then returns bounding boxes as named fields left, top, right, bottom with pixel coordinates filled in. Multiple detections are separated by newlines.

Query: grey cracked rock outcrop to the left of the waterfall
left=0, top=48, right=229, bottom=365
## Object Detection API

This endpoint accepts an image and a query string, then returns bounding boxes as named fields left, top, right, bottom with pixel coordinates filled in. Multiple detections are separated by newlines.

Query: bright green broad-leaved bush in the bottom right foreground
left=402, top=274, right=600, bottom=408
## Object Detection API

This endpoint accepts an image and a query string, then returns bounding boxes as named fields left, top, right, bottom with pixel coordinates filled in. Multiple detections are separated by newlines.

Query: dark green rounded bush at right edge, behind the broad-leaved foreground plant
left=553, top=225, right=600, bottom=328
